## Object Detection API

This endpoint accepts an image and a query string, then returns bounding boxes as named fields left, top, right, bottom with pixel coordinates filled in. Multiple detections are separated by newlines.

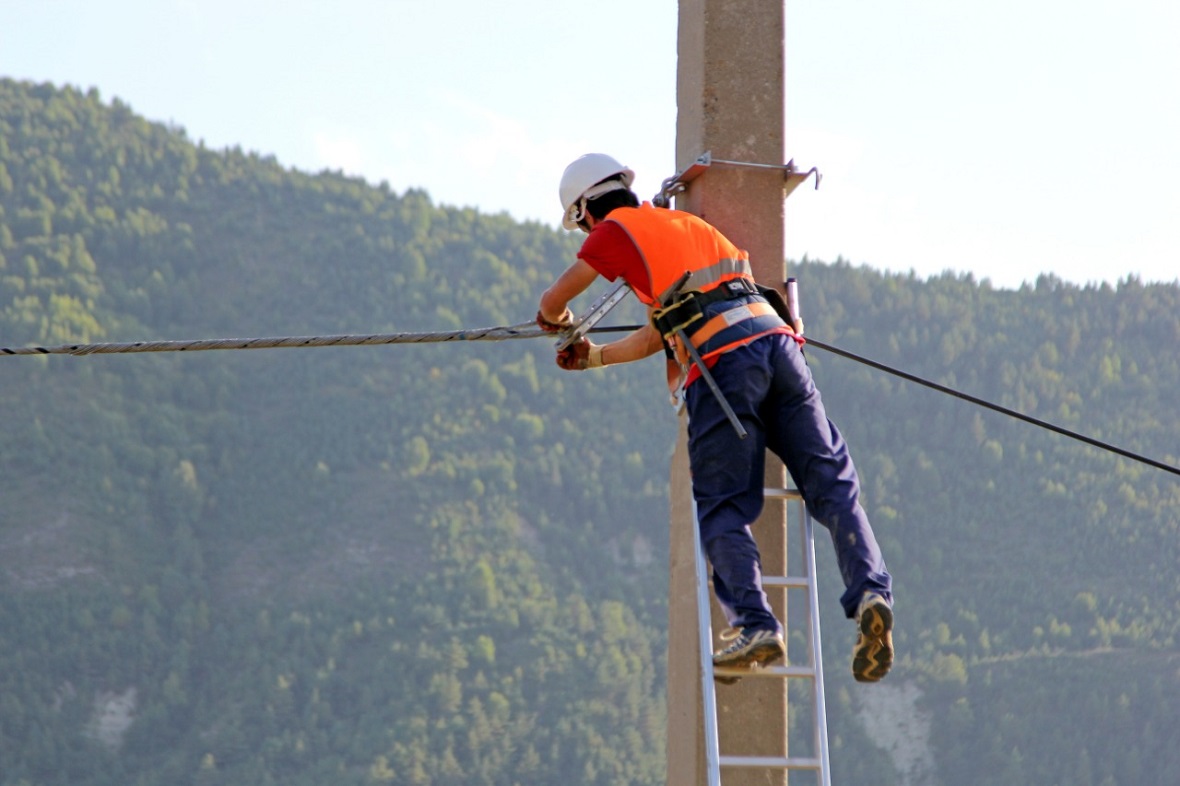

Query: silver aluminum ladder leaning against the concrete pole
left=693, top=489, right=832, bottom=786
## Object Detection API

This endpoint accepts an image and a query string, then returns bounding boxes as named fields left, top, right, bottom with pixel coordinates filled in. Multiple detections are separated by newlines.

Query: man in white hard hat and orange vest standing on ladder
left=537, top=153, right=893, bottom=682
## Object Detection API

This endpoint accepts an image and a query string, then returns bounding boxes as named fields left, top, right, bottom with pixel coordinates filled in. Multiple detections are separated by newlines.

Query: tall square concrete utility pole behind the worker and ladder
left=668, top=0, right=787, bottom=786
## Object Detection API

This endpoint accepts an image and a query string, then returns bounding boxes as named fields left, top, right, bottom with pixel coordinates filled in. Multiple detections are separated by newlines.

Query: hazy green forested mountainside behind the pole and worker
left=0, top=79, right=1180, bottom=786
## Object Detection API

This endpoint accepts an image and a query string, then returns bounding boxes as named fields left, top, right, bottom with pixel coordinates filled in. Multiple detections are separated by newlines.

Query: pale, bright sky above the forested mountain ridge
left=0, top=0, right=1180, bottom=288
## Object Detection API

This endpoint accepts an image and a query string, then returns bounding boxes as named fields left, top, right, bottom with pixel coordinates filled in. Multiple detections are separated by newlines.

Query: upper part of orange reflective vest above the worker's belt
left=605, top=203, right=754, bottom=306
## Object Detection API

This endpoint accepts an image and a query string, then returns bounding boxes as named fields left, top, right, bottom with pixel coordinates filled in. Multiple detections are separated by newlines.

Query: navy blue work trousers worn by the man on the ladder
left=686, top=334, right=892, bottom=633
